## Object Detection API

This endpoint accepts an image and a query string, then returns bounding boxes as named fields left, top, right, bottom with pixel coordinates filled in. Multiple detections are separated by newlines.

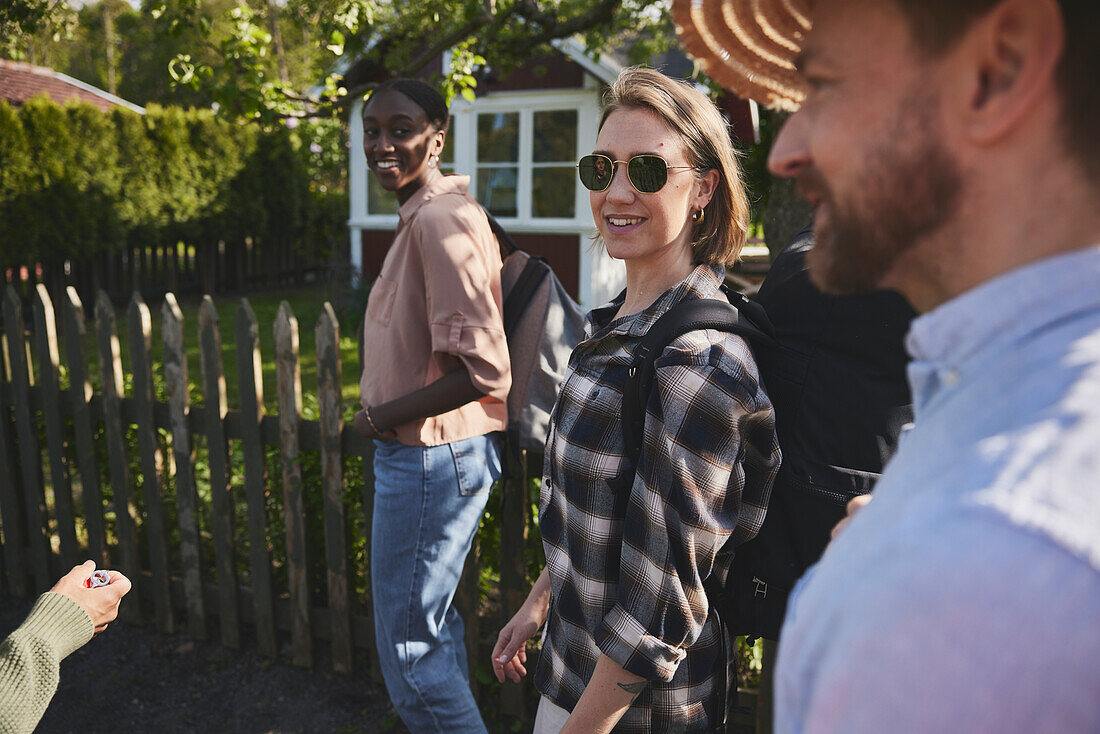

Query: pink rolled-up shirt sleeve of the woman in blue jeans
left=417, top=203, right=512, bottom=402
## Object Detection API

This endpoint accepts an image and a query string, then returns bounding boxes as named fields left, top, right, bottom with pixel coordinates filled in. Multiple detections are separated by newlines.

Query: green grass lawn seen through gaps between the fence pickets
left=87, top=286, right=359, bottom=420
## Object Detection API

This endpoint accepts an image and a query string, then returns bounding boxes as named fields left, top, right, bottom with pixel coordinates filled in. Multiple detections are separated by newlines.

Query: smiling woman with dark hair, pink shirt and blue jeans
left=355, top=79, right=512, bottom=733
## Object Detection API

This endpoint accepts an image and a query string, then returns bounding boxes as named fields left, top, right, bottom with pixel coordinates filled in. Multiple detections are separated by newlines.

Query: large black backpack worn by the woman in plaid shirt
left=623, top=228, right=914, bottom=639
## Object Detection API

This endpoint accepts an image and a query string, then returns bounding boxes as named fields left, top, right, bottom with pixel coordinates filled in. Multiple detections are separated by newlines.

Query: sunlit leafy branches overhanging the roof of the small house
left=162, top=0, right=672, bottom=123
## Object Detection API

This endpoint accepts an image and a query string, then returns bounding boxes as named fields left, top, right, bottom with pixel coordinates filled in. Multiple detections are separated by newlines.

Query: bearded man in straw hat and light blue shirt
left=672, top=0, right=1100, bottom=732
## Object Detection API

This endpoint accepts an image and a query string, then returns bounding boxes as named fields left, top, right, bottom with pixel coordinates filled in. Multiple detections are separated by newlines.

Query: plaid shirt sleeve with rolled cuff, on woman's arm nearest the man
left=595, top=331, right=779, bottom=681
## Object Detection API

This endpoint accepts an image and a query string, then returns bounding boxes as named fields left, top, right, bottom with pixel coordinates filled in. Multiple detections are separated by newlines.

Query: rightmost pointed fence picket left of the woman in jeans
left=316, top=302, right=352, bottom=672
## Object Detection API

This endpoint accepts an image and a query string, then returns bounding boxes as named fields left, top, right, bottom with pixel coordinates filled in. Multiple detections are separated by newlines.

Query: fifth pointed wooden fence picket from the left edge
left=127, top=291, right=175, bottom=632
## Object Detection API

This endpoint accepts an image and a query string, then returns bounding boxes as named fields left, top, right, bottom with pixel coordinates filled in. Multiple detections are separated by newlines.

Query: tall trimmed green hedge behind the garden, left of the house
left=0, top=97, right=347, bottom=266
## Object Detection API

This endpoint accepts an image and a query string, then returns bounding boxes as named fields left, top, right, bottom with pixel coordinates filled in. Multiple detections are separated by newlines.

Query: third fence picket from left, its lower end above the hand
left=63, top=286, right=110, bottom=568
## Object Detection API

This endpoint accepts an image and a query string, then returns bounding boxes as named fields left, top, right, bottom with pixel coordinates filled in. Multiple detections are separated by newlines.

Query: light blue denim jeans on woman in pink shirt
left=371, top=434, right=501, bottom=734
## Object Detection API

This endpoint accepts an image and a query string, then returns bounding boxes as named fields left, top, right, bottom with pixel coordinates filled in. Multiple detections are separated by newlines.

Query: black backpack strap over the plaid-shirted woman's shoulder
left=623, top=293, right=774, bottom=471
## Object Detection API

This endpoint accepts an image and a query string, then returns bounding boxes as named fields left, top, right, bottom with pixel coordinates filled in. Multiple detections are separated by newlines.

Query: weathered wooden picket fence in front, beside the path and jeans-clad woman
left=0, top=284, right=529, bottom=715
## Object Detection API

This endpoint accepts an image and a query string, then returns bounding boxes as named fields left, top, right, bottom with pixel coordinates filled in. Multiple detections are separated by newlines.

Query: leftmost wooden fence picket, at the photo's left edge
left=3, top=286, right=53, bottom=591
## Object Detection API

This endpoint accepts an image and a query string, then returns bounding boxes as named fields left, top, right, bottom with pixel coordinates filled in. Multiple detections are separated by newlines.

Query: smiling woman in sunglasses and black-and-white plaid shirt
left=493, top=68, right=779, bottom=734
